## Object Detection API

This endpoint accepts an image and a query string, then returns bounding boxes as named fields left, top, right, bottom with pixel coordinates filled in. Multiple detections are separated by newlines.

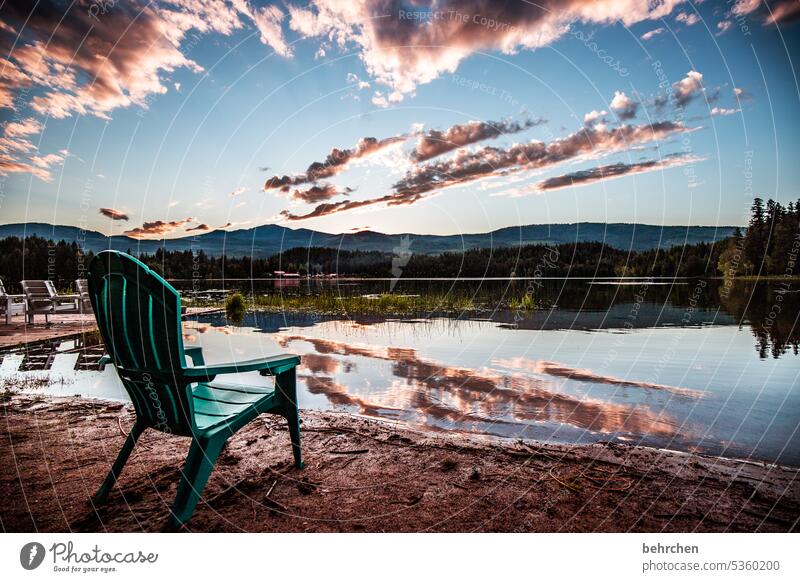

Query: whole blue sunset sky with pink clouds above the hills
left=0, top=0, right=800, bottom=238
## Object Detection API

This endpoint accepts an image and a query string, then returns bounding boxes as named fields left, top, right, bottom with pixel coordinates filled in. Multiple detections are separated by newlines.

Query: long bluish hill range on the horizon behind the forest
left=0, top=222, right=735, bottom=257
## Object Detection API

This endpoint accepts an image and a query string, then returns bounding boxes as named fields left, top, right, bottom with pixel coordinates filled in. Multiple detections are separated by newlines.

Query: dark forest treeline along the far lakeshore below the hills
left=0, top=198, right=800, bottom=290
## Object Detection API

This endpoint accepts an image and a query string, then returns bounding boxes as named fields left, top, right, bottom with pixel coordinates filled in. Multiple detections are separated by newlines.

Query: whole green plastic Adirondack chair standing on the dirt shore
left=89, top=251, right=303, bottom=528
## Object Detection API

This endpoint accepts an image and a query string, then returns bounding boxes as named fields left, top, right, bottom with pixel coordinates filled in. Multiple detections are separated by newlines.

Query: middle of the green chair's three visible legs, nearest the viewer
left=168, top=436, right=226, bottom=529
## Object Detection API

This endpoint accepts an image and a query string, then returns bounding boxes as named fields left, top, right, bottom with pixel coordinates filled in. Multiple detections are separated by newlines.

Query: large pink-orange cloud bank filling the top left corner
left=0, top=0, right=290, bottom=118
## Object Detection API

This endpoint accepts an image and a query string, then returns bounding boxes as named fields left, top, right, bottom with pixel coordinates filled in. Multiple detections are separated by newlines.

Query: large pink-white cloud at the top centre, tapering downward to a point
left=288, top=0, right=683, bottom=98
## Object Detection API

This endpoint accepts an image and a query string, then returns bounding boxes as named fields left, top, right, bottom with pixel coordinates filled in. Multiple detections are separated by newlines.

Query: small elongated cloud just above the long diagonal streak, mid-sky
left=413, top=119, right=544, bottom=162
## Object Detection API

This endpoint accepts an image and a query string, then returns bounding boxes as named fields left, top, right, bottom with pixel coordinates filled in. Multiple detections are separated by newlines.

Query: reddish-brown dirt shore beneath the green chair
left=0, top=395, right=800, bottom=532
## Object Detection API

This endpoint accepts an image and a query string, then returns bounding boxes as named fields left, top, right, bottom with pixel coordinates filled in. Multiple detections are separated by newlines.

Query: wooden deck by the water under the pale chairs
left=0, top=307, right=222, bottom=349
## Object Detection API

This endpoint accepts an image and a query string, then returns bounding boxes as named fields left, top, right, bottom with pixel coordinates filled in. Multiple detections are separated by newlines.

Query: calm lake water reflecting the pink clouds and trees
left=0, top=281, right=800, bottom=465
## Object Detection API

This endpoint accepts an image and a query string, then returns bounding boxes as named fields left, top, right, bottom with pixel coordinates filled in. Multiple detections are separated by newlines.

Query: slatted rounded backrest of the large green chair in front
left=88, top=251, right=194, bottom=435
